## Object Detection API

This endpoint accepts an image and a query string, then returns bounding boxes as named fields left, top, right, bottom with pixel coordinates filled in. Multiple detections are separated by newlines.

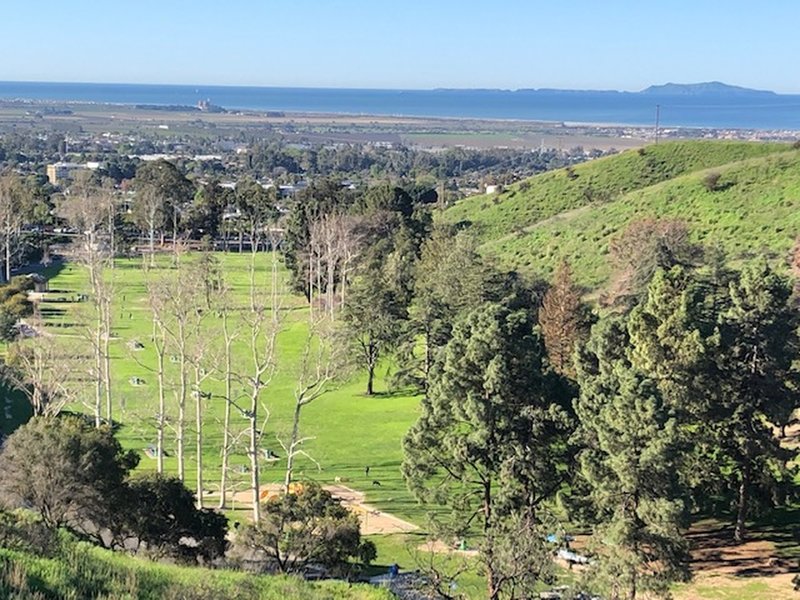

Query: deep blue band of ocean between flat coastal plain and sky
left=0, top=82, right=800, bottom=130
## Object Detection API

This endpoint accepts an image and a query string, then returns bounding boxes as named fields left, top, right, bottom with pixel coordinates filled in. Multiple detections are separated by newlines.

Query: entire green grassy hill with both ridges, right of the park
left=443, top=142, right=800, bottom=288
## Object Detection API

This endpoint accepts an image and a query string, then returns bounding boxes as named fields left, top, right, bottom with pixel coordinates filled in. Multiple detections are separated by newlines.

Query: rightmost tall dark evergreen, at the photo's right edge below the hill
left=718, top=262, right=800, bottom=541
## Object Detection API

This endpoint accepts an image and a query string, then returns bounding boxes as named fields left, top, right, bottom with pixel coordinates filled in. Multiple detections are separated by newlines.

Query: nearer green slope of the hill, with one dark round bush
left=484, top=151, right=800, bottom=287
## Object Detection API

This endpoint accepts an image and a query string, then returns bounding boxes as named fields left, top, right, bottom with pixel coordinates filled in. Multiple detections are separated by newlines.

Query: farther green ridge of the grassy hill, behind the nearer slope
left=444, top=141, right=787, bottom=240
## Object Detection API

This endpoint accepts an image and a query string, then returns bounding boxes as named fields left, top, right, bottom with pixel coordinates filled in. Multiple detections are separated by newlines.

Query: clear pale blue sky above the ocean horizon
left=0, top=0, right=800, bottom=93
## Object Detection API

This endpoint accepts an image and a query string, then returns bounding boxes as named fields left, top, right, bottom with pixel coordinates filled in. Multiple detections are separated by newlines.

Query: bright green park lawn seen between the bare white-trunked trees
left=36, top=254, right=421, bottom=522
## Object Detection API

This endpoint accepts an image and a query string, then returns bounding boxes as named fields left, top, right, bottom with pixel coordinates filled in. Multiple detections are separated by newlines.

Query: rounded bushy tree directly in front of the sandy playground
left=236, top=482, right=375, bottom=574
